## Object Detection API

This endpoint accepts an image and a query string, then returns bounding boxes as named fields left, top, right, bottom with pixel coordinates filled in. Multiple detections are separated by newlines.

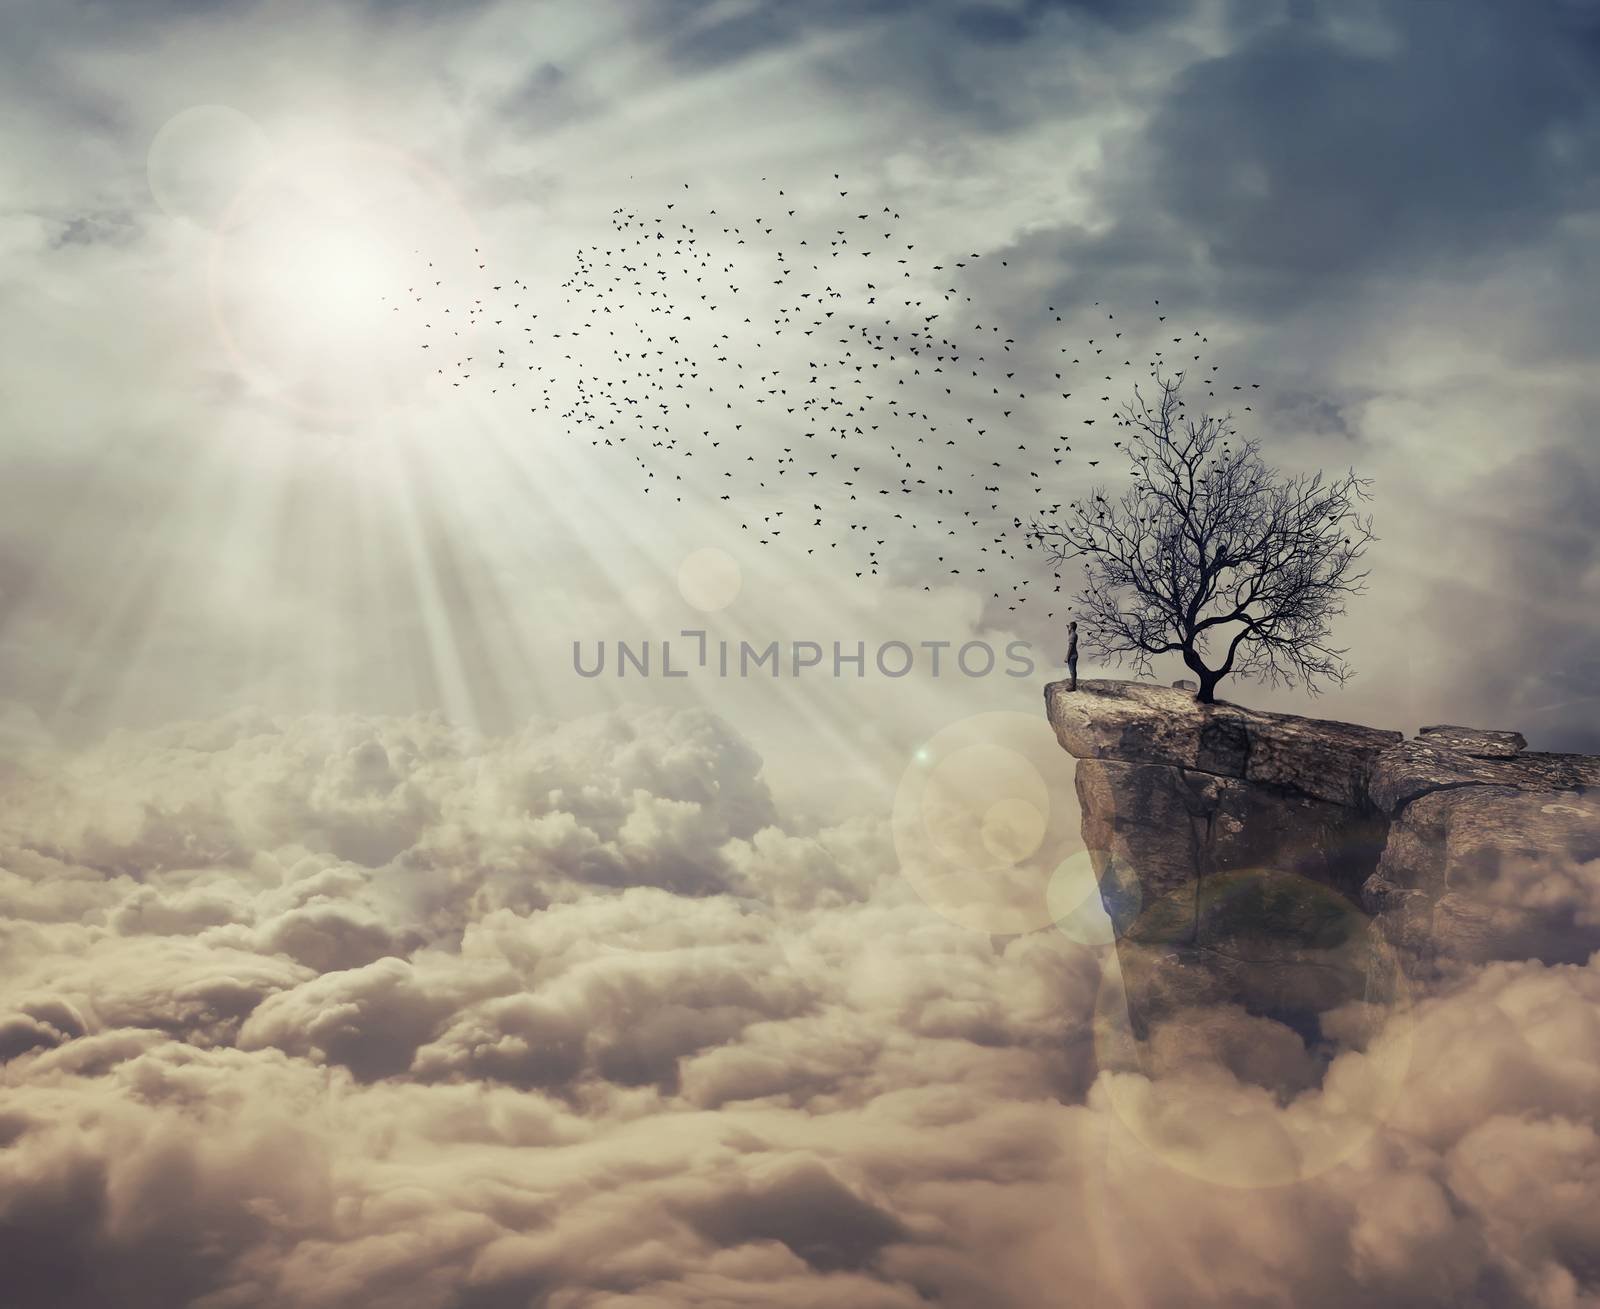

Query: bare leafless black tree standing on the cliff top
left=1029, top=371, right=1378, bottom=704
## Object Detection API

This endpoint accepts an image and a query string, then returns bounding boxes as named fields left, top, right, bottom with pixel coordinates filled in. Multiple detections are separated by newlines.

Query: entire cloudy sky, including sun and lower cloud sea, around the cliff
left=0, top=0, right=1600, bottom=1309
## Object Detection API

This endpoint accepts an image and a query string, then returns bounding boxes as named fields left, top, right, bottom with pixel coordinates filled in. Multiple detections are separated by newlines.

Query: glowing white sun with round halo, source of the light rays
left=208, top=142, right=480, bottom=422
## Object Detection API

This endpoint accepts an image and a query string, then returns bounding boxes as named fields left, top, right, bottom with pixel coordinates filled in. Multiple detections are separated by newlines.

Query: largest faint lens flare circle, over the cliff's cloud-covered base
left=1090, top=869, right=1411, bottom=1187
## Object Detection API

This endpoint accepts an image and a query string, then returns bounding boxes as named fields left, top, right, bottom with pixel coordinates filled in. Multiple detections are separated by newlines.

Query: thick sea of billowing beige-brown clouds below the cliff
left=0, top=714, right=1600, bottom=1309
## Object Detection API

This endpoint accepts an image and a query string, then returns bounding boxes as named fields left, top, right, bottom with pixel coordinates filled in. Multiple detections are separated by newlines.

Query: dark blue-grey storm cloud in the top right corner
left=1030, top=0, right=1600, bottom=310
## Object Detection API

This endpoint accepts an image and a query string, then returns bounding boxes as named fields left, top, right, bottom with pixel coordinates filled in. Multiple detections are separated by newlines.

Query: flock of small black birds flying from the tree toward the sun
left=377, top=173, right=1259, bottom=618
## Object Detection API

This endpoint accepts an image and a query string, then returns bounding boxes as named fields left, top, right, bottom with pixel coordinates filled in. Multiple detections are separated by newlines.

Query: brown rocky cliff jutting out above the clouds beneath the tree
left=1045, top=680, right=1600, bottom=1029
